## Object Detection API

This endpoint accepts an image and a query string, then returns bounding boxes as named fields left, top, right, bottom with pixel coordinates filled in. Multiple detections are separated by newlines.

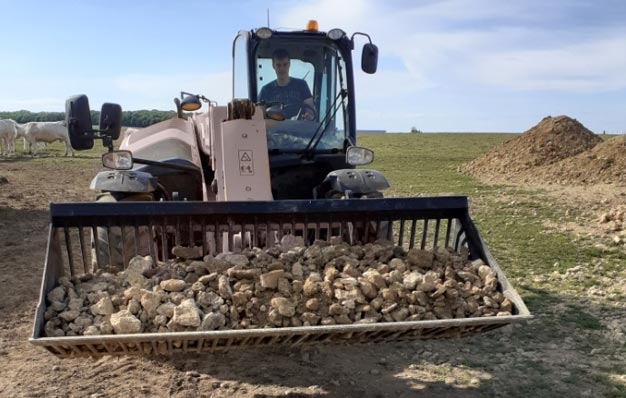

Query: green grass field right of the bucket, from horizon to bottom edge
left=359, top=134, right=626, bottom=397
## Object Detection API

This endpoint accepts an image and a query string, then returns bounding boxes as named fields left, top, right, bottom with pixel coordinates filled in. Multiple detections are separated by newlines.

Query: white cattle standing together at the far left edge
left=0, top=119, right=74, bottom=156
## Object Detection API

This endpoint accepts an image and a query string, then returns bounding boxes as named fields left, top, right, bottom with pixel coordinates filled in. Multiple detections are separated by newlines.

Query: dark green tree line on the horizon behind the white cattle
left=0, top=109, right=176, bottom=127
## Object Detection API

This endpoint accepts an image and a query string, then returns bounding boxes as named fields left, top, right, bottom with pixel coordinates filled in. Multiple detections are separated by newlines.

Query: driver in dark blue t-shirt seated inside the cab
left=259, top=48, right=316, bottom=120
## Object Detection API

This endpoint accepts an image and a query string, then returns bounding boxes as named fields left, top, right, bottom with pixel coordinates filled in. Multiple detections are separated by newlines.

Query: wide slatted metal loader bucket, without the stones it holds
left=29, top=196, right=532, bottom=358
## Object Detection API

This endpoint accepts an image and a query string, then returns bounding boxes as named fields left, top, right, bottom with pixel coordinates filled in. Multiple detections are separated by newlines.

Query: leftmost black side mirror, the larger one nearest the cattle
left=65, top=94, right=94, bottom=150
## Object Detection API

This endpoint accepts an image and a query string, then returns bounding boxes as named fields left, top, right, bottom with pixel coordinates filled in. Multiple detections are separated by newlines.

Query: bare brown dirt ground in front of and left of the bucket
left=0, top=126, right=626, bottom=398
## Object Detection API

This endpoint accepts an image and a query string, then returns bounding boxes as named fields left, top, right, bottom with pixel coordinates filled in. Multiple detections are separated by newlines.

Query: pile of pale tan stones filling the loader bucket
left=45, top=241, right=514, bottom=337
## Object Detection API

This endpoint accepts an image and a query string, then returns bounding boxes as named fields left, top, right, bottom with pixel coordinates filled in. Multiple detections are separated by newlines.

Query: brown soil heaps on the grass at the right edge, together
left=459, top=115, right=626, bottom=239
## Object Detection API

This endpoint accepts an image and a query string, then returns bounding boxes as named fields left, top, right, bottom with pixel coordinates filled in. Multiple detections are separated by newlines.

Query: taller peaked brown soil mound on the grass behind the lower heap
left=461, top=116, right=602, bottom=181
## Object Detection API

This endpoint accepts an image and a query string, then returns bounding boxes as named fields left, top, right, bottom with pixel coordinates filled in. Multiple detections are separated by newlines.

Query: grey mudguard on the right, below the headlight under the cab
left=319, top=169, right=389, bottom=195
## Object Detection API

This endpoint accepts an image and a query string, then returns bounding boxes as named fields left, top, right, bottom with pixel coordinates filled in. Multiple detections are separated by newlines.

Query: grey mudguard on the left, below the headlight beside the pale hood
left=89, top=170, right=157, bottom=192
